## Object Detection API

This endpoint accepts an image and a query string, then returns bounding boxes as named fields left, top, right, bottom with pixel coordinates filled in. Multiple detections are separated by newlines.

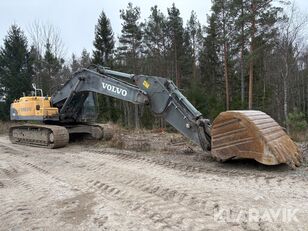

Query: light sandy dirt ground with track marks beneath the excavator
left=0, top=129, right=308, bottom=231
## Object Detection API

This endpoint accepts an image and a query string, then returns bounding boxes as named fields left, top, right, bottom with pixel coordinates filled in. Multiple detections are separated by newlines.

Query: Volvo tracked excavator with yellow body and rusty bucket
left=9, top=66, right=302, bottom=168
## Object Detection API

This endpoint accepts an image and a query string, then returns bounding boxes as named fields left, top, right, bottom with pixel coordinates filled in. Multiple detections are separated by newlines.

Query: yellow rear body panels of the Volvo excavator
left=11, top=96, right=59, bottom=118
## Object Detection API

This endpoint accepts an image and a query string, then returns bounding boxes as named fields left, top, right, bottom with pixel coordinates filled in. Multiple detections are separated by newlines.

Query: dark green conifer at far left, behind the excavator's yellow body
left=0, top=25, right=33, bottom=118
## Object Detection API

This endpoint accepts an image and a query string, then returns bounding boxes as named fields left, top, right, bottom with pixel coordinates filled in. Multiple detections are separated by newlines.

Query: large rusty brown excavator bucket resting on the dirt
left=211, top=110, right=303, bottom=168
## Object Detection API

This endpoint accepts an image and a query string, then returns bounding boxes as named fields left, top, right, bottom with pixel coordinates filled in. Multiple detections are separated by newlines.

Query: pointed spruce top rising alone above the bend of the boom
left=93, top=11, right=114, bottom=65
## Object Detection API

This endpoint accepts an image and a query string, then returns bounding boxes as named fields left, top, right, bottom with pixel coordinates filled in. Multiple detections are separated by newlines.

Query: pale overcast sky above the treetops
left=0, top=0, right=308, bottom=57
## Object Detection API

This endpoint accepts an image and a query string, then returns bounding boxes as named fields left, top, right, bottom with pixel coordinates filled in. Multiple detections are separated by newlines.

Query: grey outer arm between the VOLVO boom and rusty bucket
left=134, top=75, right=211, bottom=151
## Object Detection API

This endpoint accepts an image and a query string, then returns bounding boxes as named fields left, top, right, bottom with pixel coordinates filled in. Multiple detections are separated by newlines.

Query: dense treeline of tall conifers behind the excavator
left=0, top=0, right=308, bottom=134
